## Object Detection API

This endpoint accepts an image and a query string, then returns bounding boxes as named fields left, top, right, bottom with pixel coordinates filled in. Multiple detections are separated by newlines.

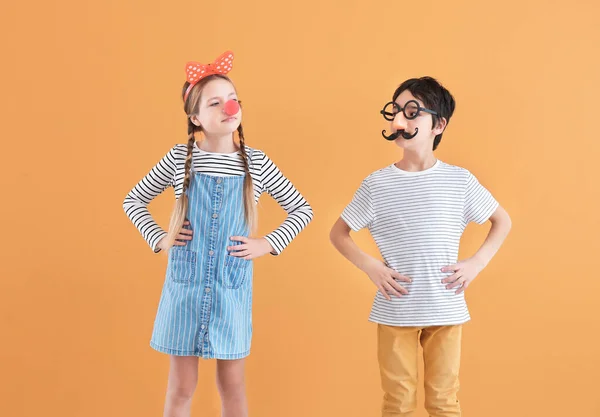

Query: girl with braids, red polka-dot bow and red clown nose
left=123, top=51, right=313, bottom=417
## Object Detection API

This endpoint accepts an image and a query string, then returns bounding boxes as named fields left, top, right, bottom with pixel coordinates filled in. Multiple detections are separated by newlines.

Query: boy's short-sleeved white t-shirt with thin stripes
left=342, top=160, right=498, bottom=326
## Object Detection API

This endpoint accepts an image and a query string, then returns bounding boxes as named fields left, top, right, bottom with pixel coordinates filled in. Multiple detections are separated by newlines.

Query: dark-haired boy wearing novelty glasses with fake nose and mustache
left=330, top=77, right=511, bottom=417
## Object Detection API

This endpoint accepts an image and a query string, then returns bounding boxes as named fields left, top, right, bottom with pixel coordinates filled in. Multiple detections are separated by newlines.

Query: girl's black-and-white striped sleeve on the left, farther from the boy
left=123, top=147, right=176, bottom=252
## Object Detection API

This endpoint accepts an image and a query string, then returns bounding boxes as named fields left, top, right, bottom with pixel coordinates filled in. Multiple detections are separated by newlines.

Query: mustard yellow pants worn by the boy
left=377, top=324, right=462, bottom=417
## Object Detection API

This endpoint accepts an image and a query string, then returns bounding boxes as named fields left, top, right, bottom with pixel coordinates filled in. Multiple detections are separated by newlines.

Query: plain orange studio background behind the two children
left=0, top=0, right=600, bottom=417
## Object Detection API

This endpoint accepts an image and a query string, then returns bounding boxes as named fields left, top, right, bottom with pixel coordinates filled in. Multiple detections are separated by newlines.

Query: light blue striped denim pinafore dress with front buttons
left=150, top=172, right=253, bottom=359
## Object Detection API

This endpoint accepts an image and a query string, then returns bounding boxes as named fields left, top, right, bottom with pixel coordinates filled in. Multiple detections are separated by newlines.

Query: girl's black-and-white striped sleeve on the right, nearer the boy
left=260, top=153, right=313, bottom=255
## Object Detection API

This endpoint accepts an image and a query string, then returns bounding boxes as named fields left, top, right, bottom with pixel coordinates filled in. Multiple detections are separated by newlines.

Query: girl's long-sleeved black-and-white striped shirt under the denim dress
left=123, top=144, right=313, bottom=255
